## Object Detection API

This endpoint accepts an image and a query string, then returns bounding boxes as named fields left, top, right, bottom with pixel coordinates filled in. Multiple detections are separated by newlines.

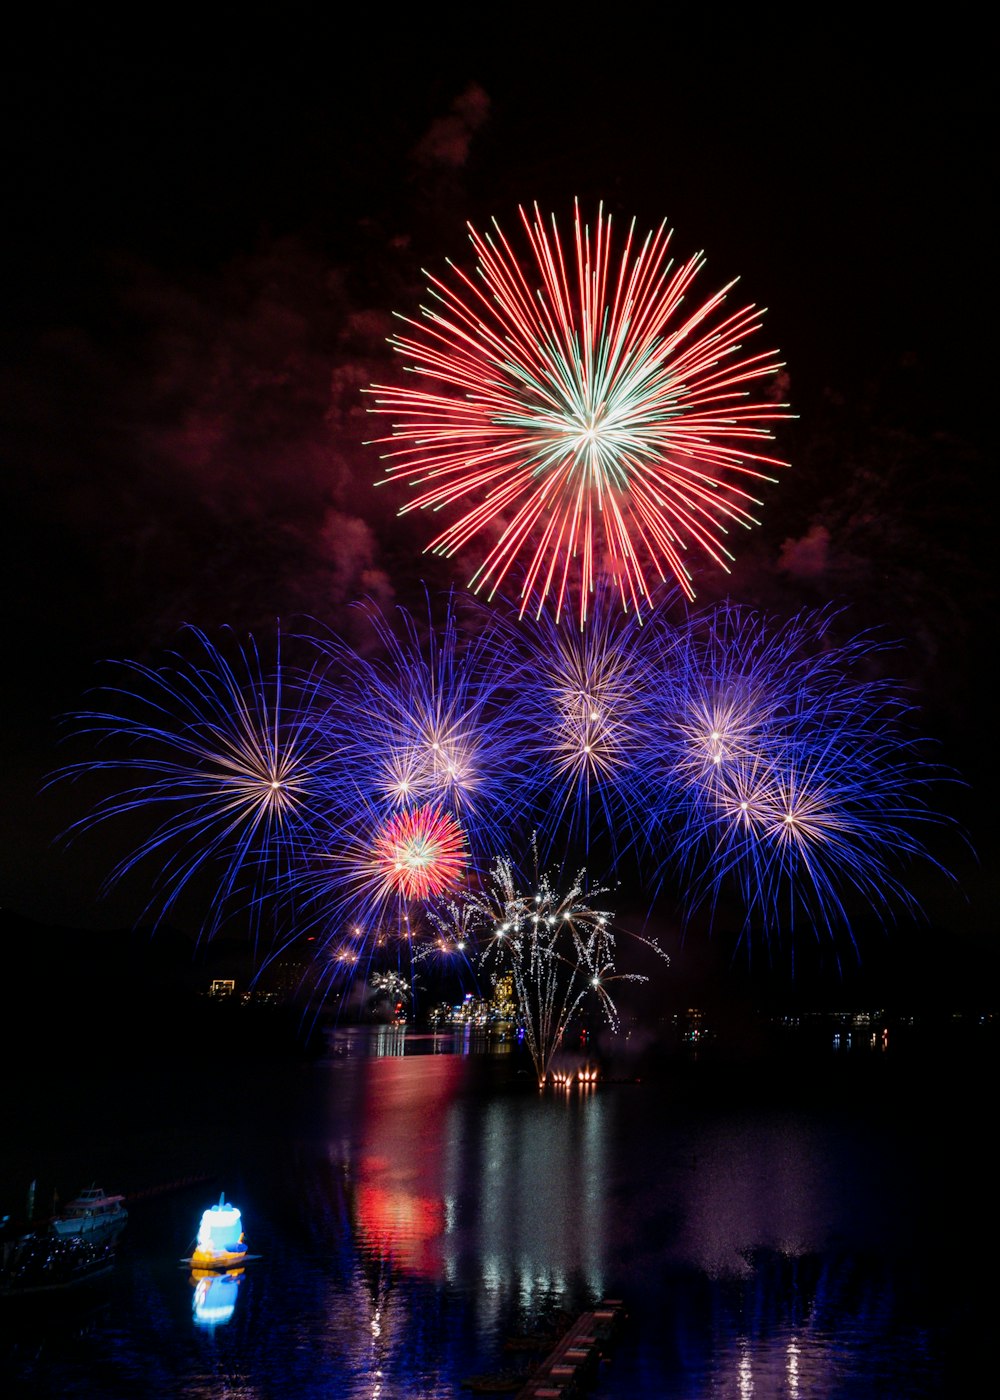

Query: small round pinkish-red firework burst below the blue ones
left=371, top=806, right=468, bottom=899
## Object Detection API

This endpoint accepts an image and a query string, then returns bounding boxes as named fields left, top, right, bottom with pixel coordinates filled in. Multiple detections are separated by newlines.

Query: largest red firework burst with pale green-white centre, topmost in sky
left=371, top=206, right=787, bottom=623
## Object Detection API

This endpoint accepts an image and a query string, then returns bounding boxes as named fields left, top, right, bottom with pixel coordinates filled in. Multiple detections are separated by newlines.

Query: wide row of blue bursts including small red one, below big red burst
left=52, top=589, right=944, bottom=972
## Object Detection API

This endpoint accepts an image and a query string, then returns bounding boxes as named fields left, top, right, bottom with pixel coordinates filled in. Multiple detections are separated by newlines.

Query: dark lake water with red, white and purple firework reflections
left=0, top=1028, right=996, bottom=1400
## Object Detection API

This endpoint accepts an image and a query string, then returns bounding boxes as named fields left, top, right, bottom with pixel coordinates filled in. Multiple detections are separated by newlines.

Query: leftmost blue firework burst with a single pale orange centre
left=49, top=627, right=335, bottom=937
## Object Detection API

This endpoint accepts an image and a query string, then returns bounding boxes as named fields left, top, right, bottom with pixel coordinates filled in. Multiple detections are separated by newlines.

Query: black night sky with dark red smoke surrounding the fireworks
left=0, top=19, right=997, bottom=1008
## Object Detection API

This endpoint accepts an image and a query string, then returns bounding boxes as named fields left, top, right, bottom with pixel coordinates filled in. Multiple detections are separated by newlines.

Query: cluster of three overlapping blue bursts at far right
left=648, top=605, right=945, bottom=938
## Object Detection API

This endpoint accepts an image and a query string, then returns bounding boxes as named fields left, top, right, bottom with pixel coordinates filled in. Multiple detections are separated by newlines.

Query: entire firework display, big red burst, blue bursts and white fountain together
left=48, top=206, right=948, bottom=1008
